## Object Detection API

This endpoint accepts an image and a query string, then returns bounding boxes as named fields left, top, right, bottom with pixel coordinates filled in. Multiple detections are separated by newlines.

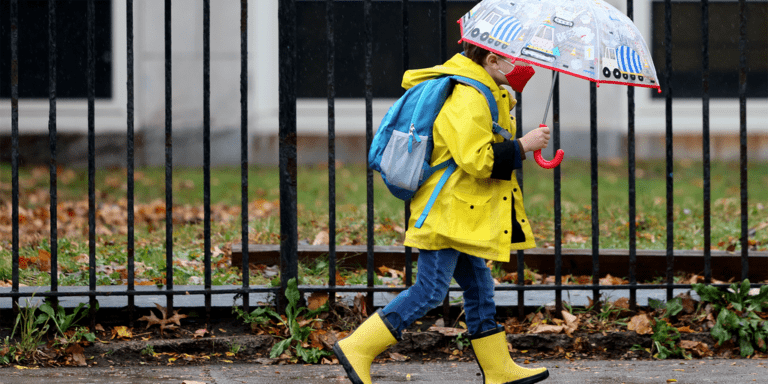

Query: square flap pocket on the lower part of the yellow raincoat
left=448, top=191, right=492, bottom=241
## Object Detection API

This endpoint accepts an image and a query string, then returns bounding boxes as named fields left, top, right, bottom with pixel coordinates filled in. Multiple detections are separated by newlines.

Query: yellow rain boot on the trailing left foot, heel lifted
left=333, top=311, right=397, bottom=384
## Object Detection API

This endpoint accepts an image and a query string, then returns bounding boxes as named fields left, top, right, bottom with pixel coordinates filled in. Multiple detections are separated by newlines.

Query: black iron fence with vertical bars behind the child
left=0, top=0, right=766, bottom=319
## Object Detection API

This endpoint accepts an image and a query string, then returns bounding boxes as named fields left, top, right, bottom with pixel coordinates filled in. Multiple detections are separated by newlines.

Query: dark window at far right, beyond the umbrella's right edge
left=652, top=1, right=768, bottom=98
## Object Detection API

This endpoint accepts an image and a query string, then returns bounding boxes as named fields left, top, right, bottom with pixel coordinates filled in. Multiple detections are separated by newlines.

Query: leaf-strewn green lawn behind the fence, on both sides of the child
left=0, top=160, right=768, bottom=285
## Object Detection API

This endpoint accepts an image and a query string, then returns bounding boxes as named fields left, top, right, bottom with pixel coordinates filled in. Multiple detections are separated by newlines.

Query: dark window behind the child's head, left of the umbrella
left=296, top=0, right=477, bottom=98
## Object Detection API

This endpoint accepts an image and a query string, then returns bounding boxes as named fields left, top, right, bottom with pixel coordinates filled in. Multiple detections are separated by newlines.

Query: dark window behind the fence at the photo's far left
left=0, top=0, right=112, bottom=99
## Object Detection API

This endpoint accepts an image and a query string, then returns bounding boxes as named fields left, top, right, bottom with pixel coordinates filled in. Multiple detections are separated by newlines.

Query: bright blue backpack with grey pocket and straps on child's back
left=368, top=75, right=512, bottom=228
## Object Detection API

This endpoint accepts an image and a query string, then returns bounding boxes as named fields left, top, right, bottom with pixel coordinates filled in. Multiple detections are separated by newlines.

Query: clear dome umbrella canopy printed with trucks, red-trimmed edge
left=459, top=0, right=660, bottom=92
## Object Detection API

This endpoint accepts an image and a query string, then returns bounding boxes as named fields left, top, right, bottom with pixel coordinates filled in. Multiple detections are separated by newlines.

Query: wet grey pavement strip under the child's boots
left=0, top=359, right=768, bottom=384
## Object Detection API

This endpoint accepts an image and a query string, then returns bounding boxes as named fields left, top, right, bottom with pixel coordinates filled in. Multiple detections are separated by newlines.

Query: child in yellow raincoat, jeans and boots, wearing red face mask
left=333, top=42, right=550, bottom=384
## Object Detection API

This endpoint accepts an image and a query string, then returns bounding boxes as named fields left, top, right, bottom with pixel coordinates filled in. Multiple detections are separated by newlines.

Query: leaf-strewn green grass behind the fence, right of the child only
left=524, top=161, right=768, bottom=250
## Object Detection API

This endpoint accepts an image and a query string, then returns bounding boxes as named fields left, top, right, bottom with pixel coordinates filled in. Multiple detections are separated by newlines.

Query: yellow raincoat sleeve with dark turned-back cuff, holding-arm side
left=435, top=85, right=523, bottom=180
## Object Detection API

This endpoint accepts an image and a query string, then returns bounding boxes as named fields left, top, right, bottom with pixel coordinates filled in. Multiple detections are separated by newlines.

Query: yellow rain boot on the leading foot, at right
left=470, top=327, right=549, bottom=384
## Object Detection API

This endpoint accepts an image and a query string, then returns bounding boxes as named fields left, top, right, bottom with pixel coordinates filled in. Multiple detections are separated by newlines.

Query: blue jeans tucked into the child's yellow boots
left=381, top=248, right=497, bottom=339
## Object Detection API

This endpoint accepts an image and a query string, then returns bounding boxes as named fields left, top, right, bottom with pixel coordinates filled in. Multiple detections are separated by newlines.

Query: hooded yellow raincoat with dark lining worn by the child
left=402, top=54, right=536, bottom=262
